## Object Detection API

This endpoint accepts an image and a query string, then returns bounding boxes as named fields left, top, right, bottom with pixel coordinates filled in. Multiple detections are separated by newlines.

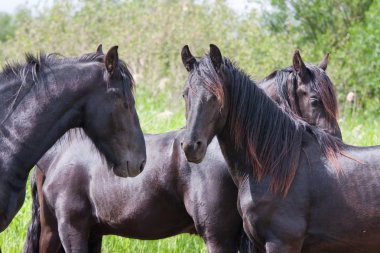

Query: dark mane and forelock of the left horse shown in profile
left=0, top=52, right=135, bottom=124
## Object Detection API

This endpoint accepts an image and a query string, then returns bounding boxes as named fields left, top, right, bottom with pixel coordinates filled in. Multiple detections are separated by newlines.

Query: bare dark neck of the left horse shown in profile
left=0, top=62, right=102, bottom=182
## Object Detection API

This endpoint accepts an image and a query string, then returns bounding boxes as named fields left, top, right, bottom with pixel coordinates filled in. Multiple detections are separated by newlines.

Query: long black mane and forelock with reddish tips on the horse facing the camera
left=189, top=55, right=343, bottom=195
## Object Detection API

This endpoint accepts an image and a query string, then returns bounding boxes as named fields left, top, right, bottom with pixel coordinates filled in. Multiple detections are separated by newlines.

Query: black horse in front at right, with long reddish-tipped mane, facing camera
left=182, top=45, right=380, bottom=253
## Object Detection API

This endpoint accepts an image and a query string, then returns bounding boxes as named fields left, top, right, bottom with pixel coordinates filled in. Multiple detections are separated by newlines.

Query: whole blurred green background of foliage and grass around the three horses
left=0, top=0, right=380, bottom=253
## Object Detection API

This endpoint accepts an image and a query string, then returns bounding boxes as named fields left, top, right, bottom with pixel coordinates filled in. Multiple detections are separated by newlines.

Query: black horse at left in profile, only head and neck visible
left=0, top=46, right=146, bottom=232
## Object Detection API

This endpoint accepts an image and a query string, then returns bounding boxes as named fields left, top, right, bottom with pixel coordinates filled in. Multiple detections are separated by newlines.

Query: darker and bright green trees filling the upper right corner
left=260, top=0, right=380, bottom=115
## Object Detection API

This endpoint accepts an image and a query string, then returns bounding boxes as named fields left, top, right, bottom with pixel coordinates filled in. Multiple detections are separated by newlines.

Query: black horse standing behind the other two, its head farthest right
left=24, top=52, right=339, bottom=252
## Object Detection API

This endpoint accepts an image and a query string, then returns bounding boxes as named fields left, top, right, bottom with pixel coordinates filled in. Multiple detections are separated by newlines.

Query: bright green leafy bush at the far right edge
left=337, top=1, right=380, bottom=115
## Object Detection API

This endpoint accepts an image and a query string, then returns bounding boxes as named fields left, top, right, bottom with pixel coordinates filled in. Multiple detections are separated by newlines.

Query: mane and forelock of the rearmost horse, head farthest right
left=262, top=64, right=339, bottom=130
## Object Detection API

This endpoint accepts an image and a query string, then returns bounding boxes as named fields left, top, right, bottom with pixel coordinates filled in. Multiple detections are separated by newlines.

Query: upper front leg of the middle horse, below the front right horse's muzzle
left=184, top=174, right=242, bottom=253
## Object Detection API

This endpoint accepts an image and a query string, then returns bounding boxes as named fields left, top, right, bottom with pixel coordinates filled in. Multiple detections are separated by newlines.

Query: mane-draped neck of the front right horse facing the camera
left=218, top=72, right=303, bottom=191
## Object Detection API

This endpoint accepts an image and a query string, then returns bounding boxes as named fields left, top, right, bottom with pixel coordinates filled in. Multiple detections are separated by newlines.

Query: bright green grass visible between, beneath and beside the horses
left=0, top=88, right=380, bottom=253
